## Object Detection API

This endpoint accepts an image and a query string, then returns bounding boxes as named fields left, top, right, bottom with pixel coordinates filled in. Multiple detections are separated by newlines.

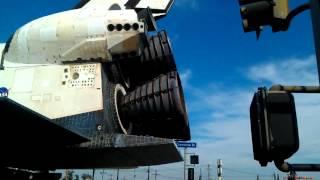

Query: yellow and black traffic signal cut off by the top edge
left=239, top=0, right=289, bottom=33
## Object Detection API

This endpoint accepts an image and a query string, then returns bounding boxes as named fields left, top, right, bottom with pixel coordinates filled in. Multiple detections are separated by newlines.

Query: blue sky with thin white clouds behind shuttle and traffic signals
left=0, top=0, right=320, bottom=180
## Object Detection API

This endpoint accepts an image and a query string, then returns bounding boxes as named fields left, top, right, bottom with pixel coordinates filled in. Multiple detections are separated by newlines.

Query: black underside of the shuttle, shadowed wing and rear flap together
left=0, top=98, right=182, bottom=170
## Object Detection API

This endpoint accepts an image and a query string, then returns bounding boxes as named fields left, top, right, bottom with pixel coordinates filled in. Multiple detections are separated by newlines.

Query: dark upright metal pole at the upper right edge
left=310, top=0, right=320, bottom=82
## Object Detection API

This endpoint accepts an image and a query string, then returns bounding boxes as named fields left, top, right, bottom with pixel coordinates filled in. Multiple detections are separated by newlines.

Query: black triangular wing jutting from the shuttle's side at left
left=0, top=97, right=89, bottom=148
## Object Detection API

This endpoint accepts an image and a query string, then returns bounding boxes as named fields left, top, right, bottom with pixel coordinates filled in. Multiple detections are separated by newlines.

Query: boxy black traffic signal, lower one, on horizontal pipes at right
left=250, top=88, right=299, bottom=166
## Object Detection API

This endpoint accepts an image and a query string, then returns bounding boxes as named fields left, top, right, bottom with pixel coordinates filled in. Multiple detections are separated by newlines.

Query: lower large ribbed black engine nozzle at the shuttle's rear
left=118, top=71, right=190, bottom=140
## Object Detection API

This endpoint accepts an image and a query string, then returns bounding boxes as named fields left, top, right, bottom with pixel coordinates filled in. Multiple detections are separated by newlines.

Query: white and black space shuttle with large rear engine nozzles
left=0, top=0, right=191, bottom=173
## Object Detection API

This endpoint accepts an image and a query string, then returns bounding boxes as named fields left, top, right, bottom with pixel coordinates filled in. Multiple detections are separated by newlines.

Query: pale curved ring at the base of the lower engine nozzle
left=105, top=82, right=133, bottom=134
